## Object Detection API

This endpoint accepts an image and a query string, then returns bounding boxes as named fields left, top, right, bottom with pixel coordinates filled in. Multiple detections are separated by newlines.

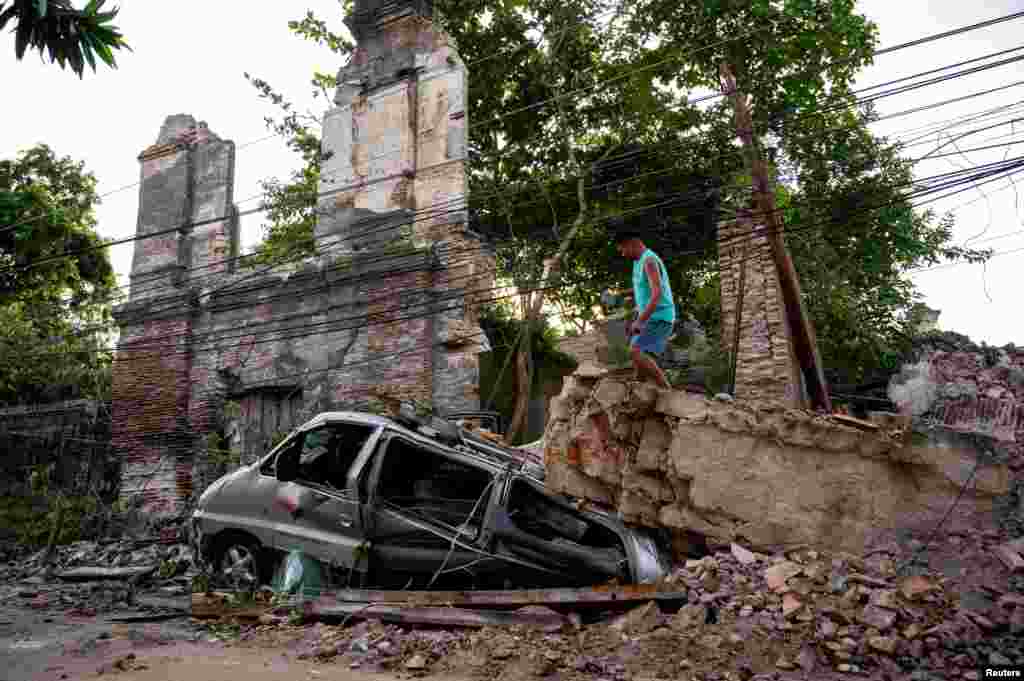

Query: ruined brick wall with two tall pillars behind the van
left=113, top=2, right=495, bottom=513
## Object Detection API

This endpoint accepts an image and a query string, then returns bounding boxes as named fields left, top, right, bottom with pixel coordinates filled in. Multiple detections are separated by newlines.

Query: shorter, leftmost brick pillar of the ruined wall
left=112, top=115, right=238, bottom=514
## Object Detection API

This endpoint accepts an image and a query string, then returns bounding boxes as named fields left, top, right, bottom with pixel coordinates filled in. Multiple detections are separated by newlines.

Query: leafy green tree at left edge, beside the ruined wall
left=0, top=145, right=115, bottom=403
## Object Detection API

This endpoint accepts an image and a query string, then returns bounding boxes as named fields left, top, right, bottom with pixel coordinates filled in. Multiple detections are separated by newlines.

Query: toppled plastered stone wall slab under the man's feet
left=545, top=366, right=1010, bottom=551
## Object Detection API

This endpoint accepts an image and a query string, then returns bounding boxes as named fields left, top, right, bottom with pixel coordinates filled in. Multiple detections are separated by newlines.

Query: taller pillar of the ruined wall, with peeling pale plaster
left=315, top=0, right=494, bottom=411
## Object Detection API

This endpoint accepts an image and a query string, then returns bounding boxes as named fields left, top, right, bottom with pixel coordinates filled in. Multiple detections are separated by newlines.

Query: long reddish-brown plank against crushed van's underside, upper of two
left=307, top=584, right=686, bottom=608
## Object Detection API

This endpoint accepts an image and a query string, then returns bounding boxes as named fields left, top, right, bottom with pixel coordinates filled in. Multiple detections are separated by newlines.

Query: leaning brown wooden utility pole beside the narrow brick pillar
left=720, top=63, right=833, bottom=414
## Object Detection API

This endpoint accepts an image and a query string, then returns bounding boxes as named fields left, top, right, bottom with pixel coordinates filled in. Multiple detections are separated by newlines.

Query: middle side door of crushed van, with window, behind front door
left=367, top=433, right=500, bottom=589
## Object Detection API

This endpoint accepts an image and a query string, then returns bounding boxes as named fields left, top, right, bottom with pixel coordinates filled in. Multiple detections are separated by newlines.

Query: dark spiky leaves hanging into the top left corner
left=0, top=0, right=131, bottom=78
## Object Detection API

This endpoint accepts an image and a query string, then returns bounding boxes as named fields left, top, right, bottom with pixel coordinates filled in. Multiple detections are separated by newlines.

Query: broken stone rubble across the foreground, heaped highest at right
left=193, top=531, right=1024, bottom=681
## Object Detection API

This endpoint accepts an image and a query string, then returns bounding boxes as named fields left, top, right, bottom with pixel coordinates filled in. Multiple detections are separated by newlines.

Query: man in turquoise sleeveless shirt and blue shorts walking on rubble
left=615, top=229, right=676, bottom=389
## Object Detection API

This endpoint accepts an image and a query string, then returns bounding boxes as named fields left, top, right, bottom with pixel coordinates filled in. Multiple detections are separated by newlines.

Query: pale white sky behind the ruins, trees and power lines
left=0, top=0, right=1024, bottom=345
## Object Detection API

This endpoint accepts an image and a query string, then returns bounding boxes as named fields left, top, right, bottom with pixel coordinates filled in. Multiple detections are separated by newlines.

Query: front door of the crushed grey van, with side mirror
left=278, top=423, right=374, bottom=569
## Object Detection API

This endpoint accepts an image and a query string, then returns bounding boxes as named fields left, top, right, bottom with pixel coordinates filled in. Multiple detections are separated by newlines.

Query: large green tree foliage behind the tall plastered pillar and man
left=249, top=0, right=986, bottom=395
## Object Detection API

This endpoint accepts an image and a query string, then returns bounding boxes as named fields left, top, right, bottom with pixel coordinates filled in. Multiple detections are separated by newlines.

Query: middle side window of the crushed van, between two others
left=377, top=438, right=494, bottom=537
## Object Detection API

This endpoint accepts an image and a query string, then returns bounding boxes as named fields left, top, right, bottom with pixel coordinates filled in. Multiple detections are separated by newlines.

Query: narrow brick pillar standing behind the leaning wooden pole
left=718, top=210, right=802, bottom=407
